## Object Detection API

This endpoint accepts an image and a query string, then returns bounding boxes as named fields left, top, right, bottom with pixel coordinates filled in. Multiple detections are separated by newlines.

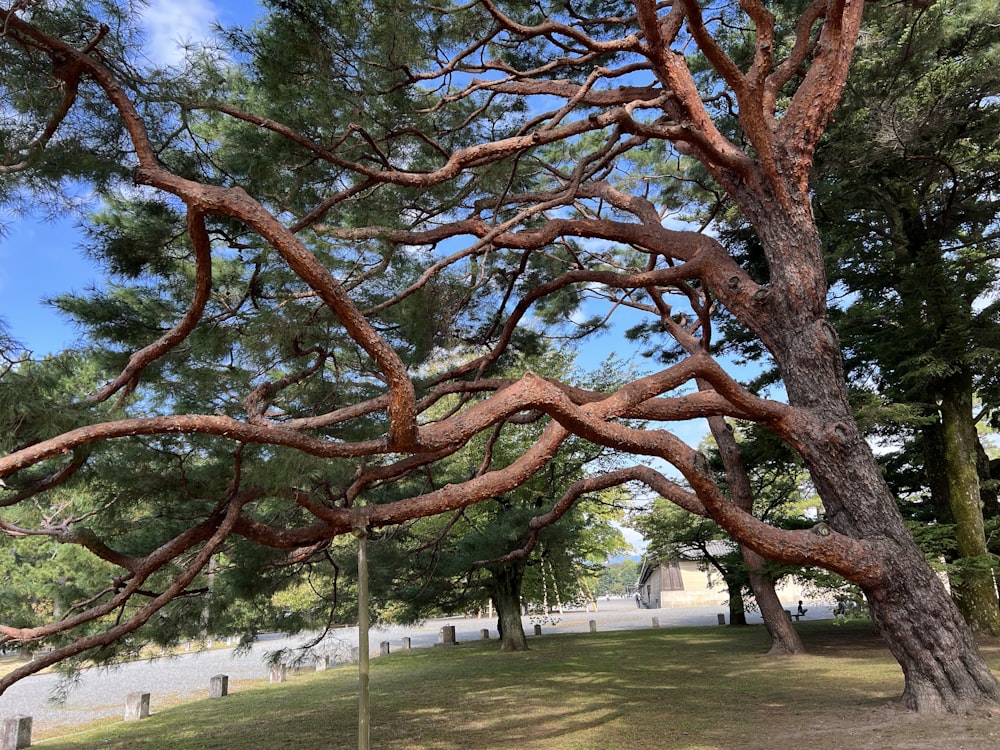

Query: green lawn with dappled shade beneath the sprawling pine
left=27, top=622, right=1000, bottom=750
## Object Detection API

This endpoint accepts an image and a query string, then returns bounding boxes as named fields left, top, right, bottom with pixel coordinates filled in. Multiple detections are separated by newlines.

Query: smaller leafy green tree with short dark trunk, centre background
left=382, top=351, right=628, bottom=651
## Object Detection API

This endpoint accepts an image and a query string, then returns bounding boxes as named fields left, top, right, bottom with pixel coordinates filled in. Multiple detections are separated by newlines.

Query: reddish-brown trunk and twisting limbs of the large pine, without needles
left=0, top=0, right=1000, bottom=711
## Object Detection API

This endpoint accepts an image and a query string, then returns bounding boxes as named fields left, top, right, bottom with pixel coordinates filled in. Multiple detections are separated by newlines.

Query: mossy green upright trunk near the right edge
left=939, top=374, right=1000, bottom=635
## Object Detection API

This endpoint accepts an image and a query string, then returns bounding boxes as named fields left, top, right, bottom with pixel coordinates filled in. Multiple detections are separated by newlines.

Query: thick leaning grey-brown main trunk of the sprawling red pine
left=745, top=204, right=1000, bottom=711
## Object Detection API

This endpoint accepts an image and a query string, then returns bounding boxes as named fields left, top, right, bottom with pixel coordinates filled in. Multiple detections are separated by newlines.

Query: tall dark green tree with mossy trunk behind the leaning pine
left=815, top=1, right=1000, bottom=635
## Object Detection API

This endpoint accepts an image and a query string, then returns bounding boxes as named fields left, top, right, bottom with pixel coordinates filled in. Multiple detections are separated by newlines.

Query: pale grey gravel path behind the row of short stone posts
left=0, top=599, right=832, bottom=732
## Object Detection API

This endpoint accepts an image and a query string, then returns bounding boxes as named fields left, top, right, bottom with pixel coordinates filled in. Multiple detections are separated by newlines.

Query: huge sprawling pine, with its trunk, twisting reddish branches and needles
left=0, top=0, right=1000, bottom=711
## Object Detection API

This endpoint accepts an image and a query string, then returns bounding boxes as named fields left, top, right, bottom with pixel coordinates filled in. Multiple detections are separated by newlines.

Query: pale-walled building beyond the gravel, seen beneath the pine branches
left=636, top=541, right=804, bottom=609
